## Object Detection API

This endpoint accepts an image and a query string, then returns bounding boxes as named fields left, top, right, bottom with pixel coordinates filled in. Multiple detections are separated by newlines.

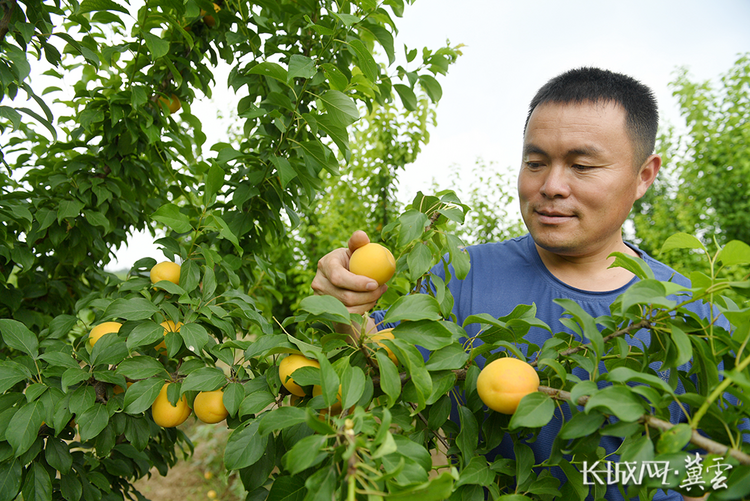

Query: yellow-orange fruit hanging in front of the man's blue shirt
left=477, top=357, right=539, bottom=414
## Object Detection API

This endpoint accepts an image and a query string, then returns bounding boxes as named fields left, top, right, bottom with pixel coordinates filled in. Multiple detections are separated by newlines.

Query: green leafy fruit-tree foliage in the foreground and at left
left=0, top=0, right=750, bottom=501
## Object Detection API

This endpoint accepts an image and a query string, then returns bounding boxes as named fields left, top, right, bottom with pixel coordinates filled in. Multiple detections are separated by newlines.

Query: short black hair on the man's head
left=523, top=67, right=659, bottom=166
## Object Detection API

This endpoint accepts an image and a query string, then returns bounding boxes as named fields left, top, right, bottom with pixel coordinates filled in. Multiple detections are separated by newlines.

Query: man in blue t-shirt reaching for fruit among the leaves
left=312, top=68, right=703, bottom=499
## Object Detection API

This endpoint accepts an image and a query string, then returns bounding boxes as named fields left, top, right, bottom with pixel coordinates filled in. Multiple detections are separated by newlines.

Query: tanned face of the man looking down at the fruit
left=518, top=102, right=659, bottom=257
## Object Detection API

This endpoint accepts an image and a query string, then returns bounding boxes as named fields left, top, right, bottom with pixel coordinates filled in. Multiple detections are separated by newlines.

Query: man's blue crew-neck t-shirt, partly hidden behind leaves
left=373, top=234, right=724, bottom=500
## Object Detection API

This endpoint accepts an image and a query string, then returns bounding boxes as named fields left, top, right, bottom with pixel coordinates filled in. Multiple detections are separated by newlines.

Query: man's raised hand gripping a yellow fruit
left=311, top=230, right=388, bottom=314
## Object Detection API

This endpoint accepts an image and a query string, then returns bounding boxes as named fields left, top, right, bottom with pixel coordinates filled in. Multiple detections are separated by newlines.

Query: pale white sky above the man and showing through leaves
left=108, top=0, right=750, bottom=269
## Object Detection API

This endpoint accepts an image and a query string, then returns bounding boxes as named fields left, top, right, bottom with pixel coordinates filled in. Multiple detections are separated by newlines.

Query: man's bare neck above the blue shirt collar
left=535, top=240, right=639, bottom=292
